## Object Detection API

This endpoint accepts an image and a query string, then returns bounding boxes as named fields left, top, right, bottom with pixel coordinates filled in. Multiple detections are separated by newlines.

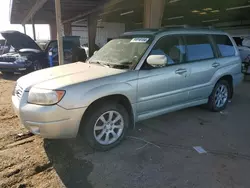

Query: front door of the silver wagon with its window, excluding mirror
left=137, top=35, right=189, bottom=120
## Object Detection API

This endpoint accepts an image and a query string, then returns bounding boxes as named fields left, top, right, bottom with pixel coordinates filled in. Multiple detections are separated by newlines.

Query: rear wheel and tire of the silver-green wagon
left=208, top=80, right=231, bottom=112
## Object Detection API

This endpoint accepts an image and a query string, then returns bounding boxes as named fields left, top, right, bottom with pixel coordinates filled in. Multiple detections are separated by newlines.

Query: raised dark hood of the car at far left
left=1, top=31, right=42, bottom=51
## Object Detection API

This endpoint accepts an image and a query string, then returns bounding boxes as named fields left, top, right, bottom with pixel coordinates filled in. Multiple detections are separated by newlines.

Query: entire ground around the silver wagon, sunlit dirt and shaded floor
left=0, top=74, right=250, bottom=188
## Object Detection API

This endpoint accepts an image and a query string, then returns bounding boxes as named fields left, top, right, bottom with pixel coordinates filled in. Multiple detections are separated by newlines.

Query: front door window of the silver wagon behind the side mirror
left=146, top=36, right=185, bottom=67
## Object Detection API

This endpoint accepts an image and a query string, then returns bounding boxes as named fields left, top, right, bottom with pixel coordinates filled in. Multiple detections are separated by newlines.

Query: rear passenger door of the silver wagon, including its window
left=184, top=34, right=220, bottom=102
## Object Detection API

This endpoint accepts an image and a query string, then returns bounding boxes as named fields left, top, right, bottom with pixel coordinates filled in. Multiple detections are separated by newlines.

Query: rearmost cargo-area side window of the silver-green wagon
left=214, top=35, right=235, bottom=57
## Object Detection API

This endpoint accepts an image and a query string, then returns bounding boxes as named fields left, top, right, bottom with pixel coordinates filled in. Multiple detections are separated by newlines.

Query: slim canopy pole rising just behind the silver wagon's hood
left=55, top=0, right=64, bottom=65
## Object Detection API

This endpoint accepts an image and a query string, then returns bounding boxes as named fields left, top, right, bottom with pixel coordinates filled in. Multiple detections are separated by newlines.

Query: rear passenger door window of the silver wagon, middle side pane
left=185, top=35, right=215, bottom=61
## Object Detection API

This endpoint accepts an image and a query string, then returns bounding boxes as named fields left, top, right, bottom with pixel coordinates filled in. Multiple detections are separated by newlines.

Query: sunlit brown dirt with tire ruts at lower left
left=0, top=74, right=60, bottom=188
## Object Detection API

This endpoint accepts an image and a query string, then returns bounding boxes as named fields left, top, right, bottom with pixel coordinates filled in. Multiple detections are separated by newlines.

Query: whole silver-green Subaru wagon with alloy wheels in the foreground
left=12, top=28, right=243, bottom=151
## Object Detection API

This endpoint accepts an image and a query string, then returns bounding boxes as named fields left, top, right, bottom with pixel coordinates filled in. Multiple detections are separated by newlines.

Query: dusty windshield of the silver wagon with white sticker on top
left=89, top=36, right=152, bottom=69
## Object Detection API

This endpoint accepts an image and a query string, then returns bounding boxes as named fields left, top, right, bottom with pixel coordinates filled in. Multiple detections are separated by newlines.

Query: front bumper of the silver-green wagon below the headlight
left=12, top=92, right=86, bottom=139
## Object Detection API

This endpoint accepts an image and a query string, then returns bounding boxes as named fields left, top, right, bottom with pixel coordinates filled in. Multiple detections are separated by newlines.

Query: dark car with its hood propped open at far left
left=0, top=31, right=48, bottom=74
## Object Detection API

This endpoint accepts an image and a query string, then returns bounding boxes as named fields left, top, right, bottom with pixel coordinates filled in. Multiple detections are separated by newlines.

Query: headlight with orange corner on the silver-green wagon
left=28, top=88, right=66, bottom=105
